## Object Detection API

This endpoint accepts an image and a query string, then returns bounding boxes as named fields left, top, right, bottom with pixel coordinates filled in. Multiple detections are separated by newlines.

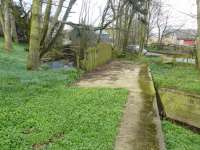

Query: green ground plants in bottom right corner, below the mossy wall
left=162, top=121, right=200, bottom=150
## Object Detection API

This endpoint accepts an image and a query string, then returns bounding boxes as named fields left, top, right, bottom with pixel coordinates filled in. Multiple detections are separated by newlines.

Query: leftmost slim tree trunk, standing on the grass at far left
left=4, top=0, right=12, bottom=51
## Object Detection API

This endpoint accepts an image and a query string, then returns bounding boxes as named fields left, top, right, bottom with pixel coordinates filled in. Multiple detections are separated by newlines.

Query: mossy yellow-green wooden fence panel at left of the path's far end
left=82, top=43, right=112, bottom=71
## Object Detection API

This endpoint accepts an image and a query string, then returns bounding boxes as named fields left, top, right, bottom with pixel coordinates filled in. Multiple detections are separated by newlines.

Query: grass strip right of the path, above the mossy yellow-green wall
left=150, top=63, right=200, bottom=94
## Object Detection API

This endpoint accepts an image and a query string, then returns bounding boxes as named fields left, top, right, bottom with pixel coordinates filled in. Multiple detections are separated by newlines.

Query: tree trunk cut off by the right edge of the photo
left=196, top=0, right=200, bottom=69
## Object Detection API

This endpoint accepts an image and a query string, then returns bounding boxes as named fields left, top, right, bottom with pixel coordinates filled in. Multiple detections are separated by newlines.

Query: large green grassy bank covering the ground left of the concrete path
left=0, top=41, right=128, bottom=150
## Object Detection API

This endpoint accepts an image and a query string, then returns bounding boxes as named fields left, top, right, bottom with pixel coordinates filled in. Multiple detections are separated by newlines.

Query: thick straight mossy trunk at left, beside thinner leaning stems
left=27, top=0, right=41, bottom=70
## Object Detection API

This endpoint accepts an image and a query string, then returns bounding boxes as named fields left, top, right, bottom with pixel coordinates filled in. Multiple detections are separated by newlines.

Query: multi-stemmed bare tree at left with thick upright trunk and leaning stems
left=27, top=0, right=76, bottom=70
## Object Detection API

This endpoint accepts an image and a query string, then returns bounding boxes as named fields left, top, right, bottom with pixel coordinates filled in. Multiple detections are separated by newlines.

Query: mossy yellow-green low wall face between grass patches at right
left=158, top=88, right=200, bottom=128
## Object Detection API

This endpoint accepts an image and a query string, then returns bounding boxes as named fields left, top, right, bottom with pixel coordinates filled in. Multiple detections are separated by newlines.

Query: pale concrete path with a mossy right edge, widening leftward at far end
left=78, top=61, right=165, bottom=150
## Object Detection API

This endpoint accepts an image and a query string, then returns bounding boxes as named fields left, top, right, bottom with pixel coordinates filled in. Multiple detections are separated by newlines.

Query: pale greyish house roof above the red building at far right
left=175, top=29, right=197, bottom=40
